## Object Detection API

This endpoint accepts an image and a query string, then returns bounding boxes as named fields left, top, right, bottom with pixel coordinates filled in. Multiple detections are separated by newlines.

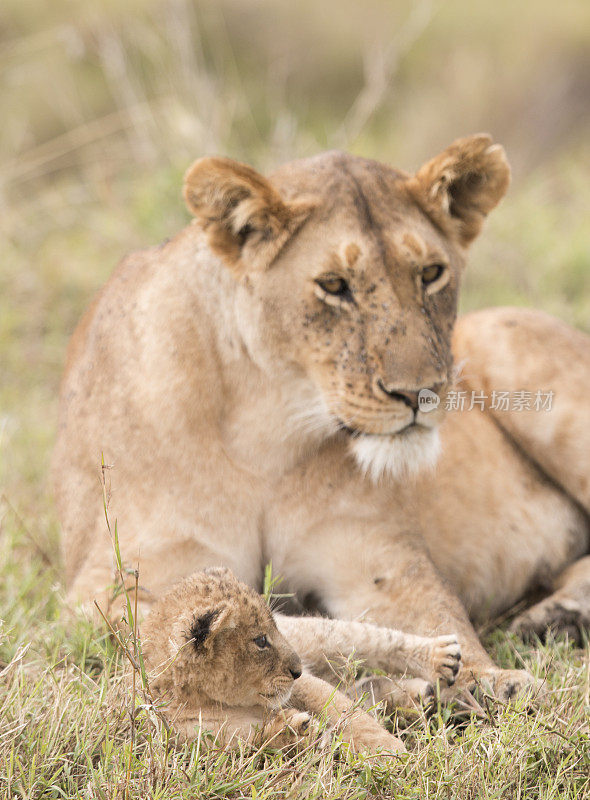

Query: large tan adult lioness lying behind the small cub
left=55, top=135, right=590, bottom=699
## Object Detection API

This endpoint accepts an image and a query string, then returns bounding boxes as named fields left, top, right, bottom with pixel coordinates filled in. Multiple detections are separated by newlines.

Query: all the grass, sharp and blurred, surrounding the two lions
left=0, top=0, right=590, bottom=800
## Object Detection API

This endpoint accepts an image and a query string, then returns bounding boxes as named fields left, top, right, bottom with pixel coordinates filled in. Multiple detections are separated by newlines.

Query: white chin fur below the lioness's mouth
left=350, top=428, right=440, bottom=483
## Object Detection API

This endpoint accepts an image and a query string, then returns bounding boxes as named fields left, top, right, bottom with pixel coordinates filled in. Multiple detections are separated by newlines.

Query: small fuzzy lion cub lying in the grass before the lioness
left=142, top=567, right=460, bottom=753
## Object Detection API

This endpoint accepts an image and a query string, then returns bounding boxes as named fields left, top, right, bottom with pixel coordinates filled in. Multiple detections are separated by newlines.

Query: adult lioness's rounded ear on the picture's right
left=408, top=133, right=510, bottom=247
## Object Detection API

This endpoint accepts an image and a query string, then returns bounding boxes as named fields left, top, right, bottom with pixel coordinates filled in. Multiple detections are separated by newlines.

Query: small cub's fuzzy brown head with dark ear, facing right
left=142, top=567, right=301, bottom=708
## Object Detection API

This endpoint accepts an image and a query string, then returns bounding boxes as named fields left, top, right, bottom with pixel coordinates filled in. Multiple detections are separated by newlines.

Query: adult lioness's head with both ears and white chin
left=184, top=134, right=510, bottom=477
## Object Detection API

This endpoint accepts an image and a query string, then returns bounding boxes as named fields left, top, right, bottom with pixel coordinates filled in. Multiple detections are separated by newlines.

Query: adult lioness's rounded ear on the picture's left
left=184, top=158, right=313, bottom=275
